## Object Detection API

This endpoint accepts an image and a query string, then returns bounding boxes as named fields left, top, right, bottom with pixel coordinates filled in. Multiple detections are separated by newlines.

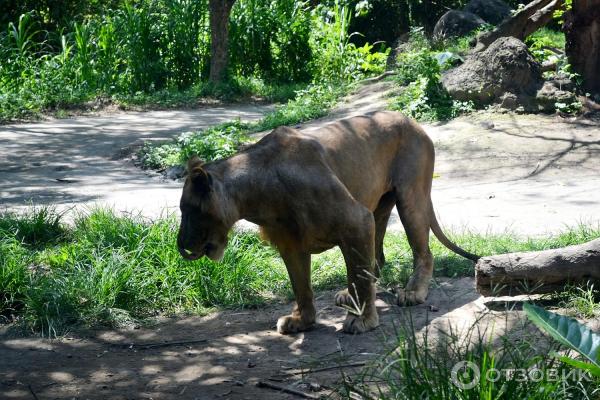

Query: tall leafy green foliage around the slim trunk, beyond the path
left=0, top=0, right=385, bottom=121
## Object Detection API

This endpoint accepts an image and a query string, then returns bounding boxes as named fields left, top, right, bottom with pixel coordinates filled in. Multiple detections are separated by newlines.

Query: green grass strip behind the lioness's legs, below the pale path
left=0, top=208, right=600, bottom=335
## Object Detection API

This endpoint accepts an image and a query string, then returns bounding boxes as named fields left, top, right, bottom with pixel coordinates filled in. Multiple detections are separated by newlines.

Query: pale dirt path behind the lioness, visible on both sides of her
left=0, top=82, right=600, bottom=235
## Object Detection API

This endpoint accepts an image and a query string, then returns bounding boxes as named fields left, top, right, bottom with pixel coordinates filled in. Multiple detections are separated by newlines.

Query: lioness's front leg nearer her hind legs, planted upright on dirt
left=335, top=213, right=379, bottom=333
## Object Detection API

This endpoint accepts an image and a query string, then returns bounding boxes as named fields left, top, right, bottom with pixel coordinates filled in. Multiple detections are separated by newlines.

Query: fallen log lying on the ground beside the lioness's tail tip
left=475, top=239, right=600, bottom=296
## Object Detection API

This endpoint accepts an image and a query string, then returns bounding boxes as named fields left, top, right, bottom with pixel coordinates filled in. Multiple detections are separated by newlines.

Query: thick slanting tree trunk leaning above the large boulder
left=475, top=0, right=564, bottom=51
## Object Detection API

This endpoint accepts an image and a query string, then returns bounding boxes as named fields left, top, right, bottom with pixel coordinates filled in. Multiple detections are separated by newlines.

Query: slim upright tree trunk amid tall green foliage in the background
left=208, top=0, right=235, bottom=82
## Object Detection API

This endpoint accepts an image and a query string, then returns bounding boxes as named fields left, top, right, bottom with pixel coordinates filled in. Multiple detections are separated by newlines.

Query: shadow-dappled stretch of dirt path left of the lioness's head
left=0, top=105, right=272, bottom=217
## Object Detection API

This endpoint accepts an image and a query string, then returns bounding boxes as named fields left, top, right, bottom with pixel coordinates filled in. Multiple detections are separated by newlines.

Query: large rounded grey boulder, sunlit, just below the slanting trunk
left=442, top=37, right=543, bottom=109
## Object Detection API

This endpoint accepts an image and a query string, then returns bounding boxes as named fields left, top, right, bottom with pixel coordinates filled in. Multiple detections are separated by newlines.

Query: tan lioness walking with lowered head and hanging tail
left=177, top=112, right=477, bottom=333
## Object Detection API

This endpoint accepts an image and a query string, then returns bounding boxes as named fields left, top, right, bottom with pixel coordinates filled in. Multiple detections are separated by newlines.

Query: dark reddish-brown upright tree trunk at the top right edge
left=565, top=0, right=600, bottom=95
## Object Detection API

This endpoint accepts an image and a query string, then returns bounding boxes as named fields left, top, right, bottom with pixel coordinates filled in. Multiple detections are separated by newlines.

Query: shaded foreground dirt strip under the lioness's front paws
left=0, top=278, right=536, bottom=399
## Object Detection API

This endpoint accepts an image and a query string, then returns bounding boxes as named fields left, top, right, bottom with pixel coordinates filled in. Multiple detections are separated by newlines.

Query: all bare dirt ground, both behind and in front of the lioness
left=0, top=83, right=600, bottom=400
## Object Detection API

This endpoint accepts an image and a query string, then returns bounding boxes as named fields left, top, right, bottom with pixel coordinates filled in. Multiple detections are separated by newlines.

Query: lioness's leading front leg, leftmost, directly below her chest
left=277, top=249, right=316, bottom=334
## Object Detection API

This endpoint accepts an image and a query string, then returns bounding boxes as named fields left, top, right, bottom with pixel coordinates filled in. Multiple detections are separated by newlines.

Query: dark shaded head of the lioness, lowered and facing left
left=177, top=157, right=232, bottom=260
